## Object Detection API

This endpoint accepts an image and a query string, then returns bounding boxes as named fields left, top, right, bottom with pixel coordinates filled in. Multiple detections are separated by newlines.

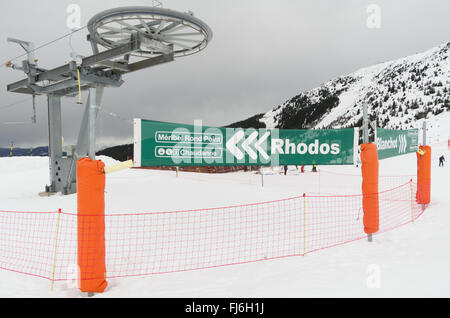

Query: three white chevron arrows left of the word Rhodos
left=226, top=130, right=270, bottom=160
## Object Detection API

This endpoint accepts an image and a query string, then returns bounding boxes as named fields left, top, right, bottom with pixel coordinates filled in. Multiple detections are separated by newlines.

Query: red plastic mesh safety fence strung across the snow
left=0, top=182, right=426, bottom=281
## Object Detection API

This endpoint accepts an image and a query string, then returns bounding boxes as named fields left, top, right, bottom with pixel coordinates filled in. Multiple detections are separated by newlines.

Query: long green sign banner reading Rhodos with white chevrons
left=134, top=119, right=357, bottom=167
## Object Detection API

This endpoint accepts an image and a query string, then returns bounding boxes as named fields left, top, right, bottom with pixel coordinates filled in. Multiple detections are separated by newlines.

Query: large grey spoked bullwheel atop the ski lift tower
left=88, top=7, right=212, bottom=58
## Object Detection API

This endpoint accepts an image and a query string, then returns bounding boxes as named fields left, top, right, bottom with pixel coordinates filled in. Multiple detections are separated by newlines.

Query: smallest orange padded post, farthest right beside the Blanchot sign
left=416, top=146, right=431, bottom=204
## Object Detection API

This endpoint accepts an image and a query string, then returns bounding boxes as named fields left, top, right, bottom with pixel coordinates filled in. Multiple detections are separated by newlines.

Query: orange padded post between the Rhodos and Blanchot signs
left=361, top=143, right=379, bottom=234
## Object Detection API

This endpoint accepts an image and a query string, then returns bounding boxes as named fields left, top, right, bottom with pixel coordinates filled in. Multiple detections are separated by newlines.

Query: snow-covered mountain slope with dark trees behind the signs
left=230, top=42, right=450, bottom=141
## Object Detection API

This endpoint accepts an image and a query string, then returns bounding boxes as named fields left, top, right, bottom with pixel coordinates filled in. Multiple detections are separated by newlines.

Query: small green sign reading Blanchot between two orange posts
left=376, top=128, right=419, bottom=159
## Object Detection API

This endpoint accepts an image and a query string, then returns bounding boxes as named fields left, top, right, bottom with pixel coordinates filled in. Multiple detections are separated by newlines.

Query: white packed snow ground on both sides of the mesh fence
left=0, top=143, right=450, bottom=297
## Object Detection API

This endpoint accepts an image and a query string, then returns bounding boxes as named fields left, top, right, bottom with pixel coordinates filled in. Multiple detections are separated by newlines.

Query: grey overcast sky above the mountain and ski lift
left=0, top=0, right=450, bottom=147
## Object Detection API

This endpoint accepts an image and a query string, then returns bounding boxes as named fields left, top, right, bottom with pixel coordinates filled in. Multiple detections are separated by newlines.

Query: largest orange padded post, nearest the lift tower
left=77, top=158, right=108, bottom=293
